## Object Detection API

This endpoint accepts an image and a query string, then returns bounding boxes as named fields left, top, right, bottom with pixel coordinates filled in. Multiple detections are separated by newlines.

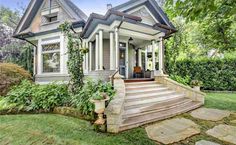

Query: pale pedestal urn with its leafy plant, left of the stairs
left=91, top=91, right=110, bottom=125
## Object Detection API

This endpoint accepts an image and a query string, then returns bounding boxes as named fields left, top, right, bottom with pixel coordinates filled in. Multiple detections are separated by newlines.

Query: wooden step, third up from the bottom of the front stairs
left=124, top=94, right=185, bottom=110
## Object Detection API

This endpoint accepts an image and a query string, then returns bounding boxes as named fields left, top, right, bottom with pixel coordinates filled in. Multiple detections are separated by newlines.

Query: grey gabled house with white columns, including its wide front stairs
left=14, top=0, right=204, bottom=132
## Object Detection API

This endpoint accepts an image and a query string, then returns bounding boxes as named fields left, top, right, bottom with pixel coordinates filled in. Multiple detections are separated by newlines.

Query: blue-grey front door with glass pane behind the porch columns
left=119, top=43, right=126, bottom=77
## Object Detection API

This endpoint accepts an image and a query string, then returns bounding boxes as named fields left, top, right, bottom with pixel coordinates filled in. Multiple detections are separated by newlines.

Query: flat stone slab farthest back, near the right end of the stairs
left=191, top=108, right=230, bottom=121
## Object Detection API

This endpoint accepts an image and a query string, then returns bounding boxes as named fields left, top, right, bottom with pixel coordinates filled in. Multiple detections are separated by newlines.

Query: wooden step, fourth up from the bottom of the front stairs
left=125, top=90, right=176, bottom=102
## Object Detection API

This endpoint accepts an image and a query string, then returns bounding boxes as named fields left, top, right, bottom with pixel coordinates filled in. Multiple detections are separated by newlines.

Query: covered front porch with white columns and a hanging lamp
left=83, top=11, right=165, bottom=80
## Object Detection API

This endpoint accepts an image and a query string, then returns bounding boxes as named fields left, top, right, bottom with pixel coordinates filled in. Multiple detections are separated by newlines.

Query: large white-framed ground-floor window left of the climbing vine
left=42, top=43, right=60, bottom=73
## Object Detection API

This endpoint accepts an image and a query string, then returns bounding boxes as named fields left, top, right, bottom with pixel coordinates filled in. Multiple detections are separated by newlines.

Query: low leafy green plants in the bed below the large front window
left=6, top=80, right=70, bottom=111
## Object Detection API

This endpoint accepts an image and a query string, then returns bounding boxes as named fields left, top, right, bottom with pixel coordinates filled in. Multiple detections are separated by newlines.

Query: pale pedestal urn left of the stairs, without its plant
left=91, top=97, right=110, bottom=125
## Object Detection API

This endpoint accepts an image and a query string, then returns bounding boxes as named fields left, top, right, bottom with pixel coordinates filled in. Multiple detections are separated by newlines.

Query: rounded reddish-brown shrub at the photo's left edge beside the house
left=0, top=63, right=32, bottom=96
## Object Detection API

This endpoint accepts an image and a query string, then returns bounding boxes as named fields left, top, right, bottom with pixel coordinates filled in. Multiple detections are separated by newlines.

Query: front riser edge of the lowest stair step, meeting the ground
left=119, top=103, right=203, bottom=131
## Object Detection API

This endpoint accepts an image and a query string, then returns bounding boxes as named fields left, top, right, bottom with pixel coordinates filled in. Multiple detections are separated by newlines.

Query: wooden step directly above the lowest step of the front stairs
left=123, top=98, right=192, bottom=119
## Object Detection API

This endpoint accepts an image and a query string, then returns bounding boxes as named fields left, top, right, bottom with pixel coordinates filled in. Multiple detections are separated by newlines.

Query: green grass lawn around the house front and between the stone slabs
left=0, top=93, right=236, bottom=145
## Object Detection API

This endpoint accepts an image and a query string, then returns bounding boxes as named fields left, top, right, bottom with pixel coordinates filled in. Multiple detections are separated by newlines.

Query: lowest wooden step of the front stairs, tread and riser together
left=120, top=102, right=202, bottom=131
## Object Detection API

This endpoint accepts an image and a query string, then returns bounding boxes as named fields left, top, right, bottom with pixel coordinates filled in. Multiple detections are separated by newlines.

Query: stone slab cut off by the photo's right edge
left=206, top=124, right=236, bottom=144
